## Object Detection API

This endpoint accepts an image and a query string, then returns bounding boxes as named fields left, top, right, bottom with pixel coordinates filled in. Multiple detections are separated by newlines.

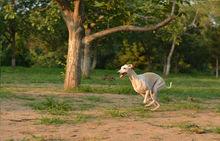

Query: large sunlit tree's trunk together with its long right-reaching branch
left=55, top=0, right=176, bottom=90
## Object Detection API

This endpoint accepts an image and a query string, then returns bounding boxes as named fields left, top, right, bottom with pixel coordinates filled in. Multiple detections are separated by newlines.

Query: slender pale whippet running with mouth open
left=118, top=64, right=172, bottom=111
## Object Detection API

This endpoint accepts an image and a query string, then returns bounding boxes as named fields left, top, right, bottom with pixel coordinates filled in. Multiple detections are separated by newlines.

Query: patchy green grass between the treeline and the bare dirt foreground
left=0, top=67, right=220, bottom=113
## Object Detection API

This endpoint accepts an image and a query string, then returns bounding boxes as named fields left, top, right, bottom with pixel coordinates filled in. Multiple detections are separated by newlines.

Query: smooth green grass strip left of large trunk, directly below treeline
left=1, top=67, right=63, bottom=85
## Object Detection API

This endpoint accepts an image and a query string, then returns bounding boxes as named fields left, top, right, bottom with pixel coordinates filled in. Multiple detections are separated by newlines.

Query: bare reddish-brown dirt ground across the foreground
left=0, top=94, right=220, bottom=141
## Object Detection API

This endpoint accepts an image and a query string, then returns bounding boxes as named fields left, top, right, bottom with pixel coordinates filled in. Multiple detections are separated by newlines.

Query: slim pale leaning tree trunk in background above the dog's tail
left=164, top=37, right=176, bottom=76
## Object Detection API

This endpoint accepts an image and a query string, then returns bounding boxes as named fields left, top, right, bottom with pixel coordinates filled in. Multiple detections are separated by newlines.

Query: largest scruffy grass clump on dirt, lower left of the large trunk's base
left=29, top=97, right=72, bottom=115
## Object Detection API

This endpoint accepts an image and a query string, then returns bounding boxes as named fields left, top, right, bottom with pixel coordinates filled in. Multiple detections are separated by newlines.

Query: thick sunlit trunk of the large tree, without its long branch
left=63, top=0, right=85, bottom=90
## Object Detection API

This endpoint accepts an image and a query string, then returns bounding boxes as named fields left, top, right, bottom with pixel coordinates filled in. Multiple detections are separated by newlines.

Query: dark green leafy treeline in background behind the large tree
left=0, top=0, right=220, bottom=75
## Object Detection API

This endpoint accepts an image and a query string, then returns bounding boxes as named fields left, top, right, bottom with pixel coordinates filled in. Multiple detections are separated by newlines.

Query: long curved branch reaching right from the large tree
left=84, top=0, right=176, bottom=44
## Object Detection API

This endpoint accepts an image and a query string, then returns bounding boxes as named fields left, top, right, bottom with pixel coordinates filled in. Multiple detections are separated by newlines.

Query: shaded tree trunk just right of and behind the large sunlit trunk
left=82, top=27, right=91, bottom=78
